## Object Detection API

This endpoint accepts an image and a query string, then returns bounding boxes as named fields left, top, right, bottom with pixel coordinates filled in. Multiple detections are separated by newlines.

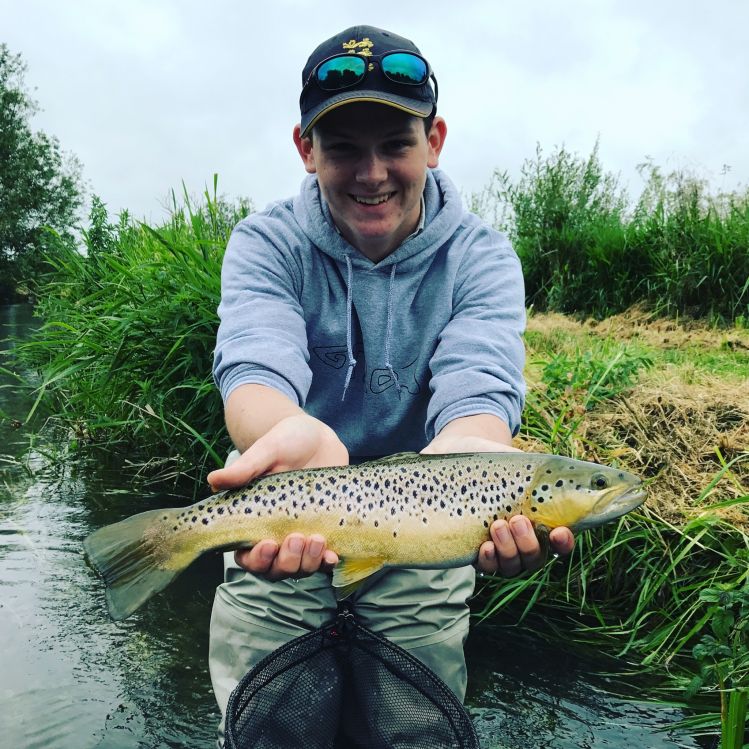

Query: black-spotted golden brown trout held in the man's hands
left=84, top=452, right=645, bottom=620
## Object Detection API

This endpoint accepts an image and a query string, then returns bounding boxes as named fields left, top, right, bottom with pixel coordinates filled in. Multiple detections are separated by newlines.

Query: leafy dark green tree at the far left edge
left=0, top=44, right=82, bottom=303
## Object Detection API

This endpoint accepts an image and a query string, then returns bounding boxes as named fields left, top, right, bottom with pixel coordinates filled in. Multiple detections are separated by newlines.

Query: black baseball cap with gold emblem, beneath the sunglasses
left=299, top=26, right=437, bottom=137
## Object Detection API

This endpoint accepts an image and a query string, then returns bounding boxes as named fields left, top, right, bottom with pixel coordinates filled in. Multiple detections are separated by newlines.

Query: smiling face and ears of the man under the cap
left=294, top=103, right=447, bottom=262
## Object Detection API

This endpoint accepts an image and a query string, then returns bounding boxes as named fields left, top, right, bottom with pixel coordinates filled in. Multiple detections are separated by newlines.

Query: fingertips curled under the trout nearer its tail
left=234, top=533, right=338, bottom=580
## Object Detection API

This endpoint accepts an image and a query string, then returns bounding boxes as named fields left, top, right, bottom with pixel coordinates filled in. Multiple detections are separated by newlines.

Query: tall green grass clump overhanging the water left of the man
left=17, top=183, right=249, bottom=475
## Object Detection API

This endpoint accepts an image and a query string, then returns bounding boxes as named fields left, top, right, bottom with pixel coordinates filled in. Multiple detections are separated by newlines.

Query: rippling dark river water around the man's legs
left=0, top=305, right=703, bottom=749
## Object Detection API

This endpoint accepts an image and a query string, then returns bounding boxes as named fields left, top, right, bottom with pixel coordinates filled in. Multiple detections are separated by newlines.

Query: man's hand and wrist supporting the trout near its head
left=422, top=414, right=575, bottom=577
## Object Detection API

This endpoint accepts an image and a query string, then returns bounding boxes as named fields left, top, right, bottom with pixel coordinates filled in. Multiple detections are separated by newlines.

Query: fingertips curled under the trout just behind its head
left=477, top=515, right=552, bottom=577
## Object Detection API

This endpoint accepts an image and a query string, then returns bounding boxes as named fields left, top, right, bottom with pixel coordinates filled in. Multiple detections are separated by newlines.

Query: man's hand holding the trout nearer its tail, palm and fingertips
left=208, top=413, right=348, bottom=580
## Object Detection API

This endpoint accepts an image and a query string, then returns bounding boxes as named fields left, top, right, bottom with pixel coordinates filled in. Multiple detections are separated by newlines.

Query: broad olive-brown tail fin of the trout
left=83, top=510, right=197, bottom=621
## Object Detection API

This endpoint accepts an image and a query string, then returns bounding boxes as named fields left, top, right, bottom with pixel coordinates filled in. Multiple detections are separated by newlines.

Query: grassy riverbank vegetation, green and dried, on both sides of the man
left=7, top=150, right=749, bottom=749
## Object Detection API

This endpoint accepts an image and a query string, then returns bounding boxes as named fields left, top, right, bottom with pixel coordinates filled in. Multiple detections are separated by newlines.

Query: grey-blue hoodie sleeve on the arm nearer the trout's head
left=426, top=226, right=525, bottom=440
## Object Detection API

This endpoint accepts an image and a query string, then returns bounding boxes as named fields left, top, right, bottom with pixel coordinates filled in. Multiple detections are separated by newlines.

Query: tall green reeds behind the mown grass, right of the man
left=472, top=144, right=749, bottom=322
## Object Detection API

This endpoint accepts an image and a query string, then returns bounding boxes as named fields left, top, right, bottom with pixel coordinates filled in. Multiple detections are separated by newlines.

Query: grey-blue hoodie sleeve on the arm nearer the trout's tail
left=213, top=214, right=312, bottom=406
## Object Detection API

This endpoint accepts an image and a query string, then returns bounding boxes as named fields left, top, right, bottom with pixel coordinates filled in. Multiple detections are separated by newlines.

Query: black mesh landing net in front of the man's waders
left=225, top=606, right=479, bottom=749
